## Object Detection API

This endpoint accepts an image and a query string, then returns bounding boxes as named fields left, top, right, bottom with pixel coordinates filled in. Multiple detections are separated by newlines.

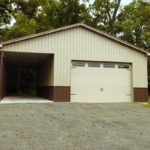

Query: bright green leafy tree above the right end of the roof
left=117, top=0, right=150, bottom=48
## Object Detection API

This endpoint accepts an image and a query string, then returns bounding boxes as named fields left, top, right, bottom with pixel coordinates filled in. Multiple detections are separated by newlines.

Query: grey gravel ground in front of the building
left=0, top=103, right=150, bottom=150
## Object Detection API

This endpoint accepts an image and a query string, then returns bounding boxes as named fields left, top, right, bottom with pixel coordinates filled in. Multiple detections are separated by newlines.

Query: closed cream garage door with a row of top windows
left=71, top=62, right=131, bottom=103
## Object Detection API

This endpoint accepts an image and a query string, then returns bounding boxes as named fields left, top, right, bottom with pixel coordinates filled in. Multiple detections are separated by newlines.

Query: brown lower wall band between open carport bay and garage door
left=37, top=86, right=70, bottom=102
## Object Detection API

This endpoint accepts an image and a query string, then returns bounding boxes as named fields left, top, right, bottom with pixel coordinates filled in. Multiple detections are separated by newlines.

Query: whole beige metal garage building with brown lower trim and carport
left=0, top=23, right=148, bottom=102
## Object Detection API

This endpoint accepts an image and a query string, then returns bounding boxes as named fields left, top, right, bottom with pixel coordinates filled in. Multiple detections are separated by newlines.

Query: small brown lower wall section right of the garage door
left=134, top=88, right=148, bottom=102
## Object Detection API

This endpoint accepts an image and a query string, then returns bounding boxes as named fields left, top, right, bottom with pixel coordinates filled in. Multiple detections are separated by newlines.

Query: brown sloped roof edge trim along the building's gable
left=0, top=23, right=149, bottom=55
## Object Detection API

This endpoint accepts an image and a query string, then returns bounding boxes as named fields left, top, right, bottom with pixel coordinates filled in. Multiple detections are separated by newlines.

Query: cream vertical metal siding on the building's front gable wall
left=3, top=27, right=147, bottom=87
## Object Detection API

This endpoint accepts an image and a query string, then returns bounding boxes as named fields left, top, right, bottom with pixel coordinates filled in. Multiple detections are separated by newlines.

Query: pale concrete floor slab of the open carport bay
left=0, top=96, right=53, bottom=104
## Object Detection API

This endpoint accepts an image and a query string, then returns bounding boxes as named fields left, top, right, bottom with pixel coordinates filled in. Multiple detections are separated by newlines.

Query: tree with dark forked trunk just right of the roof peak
left=91, top=0, right=121, bottom=35
